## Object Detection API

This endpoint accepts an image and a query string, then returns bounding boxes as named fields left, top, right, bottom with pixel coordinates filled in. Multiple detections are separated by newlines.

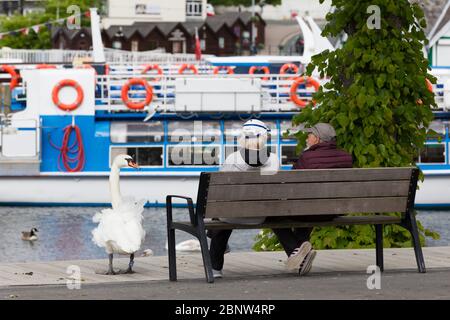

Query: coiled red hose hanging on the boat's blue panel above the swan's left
left=49, top=125, right=85, bottom=172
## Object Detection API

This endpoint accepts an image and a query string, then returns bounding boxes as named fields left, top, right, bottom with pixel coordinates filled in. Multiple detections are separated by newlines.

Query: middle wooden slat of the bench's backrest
left=208, top=180, right=410, bottom=203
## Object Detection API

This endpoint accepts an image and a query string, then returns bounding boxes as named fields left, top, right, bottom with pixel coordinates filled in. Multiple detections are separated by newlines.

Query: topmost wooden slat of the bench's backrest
left=210, top=167, right=413, bottom=186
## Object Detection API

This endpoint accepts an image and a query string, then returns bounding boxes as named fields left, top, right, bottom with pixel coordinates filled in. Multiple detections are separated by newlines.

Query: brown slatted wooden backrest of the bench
left=197, top=167, right=419, bottom=218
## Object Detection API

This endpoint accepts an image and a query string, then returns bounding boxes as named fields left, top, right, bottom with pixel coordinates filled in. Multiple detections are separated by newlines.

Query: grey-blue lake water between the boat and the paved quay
left=0, top=207, right=450, bottom=263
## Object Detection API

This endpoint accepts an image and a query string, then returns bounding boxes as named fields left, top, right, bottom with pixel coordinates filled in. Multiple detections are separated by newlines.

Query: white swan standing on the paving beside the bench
left=92, top=154, right=145, bottom=275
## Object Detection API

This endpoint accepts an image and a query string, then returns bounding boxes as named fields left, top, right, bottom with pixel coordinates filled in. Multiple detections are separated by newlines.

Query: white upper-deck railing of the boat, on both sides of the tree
left=91, top=72, right=450, bottom=112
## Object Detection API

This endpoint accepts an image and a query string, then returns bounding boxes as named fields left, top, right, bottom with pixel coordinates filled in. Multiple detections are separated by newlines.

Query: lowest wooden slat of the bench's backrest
left=205, top=197, right=407, bottom=218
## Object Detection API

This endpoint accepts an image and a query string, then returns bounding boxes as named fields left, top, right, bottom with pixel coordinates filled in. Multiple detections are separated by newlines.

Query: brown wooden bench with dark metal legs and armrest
left=166, top=167, right=426, bottom=282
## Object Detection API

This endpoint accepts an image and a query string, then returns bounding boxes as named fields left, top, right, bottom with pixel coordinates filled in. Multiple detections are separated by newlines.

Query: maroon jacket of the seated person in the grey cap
left=292, top=141, right=352, bottom=169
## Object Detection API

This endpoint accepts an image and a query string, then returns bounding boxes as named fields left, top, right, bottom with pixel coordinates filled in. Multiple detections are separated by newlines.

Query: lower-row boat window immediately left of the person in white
left=167, top=145, right=220, bottom=166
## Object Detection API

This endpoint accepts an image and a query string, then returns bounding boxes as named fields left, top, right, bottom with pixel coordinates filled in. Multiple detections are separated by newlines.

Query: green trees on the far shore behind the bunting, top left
left=0, top=0, right=104, bottom=49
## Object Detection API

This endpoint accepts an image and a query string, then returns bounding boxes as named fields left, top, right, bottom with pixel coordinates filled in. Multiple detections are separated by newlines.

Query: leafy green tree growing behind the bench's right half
left=255, top=0, right=439, bottom=250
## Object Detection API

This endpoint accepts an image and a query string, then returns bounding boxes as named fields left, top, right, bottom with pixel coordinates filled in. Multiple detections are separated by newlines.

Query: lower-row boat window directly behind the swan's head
left=110, top=147, right=163, bottom=167
